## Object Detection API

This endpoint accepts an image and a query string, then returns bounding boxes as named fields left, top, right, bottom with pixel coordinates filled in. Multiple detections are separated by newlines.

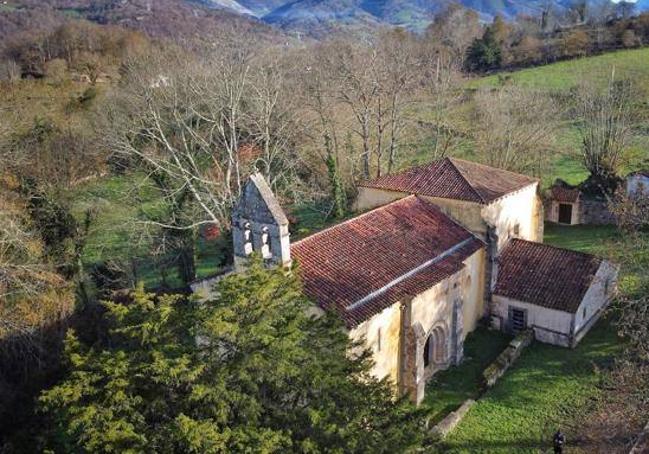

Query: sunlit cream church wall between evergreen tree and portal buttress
left=349, top=303, right=401, bottom=384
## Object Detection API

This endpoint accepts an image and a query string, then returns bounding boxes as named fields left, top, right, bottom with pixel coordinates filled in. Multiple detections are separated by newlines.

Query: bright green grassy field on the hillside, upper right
left=472, top=48, right=649, bottom=90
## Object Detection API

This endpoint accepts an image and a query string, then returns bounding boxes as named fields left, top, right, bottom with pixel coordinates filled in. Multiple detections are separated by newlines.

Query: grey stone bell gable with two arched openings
left=232, top=173, right=291, bottom=269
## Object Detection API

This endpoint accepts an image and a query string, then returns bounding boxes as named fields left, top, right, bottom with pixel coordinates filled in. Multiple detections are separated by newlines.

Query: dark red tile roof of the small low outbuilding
left=494, top=239, right=602, bottom=314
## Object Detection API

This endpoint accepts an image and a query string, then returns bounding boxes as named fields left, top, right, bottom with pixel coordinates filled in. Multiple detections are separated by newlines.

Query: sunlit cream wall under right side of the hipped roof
left=481, top=183, right=543, bottom=251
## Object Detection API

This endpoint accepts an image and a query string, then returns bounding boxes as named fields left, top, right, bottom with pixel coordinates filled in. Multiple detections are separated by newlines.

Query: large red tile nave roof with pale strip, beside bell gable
left=291, top=196, right=484, bottom=327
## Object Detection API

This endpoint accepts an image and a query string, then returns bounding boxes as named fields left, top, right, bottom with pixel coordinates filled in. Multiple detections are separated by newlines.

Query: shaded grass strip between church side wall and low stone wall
left=423, top=327, right=511, bottom=423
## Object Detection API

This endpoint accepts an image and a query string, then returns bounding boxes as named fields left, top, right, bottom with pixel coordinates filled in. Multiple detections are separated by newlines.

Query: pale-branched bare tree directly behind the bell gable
left=107, top=48, right=295, bottom=229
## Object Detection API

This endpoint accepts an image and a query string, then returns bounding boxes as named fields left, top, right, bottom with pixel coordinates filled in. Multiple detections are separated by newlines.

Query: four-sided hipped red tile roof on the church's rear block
left=360, top=158, right=538, bottom=204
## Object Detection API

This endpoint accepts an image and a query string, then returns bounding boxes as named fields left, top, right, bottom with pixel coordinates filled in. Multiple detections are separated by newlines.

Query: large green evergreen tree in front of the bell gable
left=41, top=261, right=421, bottom=452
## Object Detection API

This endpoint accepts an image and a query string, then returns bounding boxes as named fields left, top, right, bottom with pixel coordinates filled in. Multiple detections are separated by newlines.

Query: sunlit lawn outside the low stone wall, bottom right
left=440, top=320, right=621, bottom=453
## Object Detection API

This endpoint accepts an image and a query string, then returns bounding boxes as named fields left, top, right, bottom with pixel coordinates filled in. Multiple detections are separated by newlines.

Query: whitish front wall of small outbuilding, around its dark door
left=491, top=295, right=573, bottom=347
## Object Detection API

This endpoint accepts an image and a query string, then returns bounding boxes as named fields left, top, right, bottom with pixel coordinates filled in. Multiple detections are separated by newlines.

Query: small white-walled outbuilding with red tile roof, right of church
left=491, top=239, right=618, bottom=347
